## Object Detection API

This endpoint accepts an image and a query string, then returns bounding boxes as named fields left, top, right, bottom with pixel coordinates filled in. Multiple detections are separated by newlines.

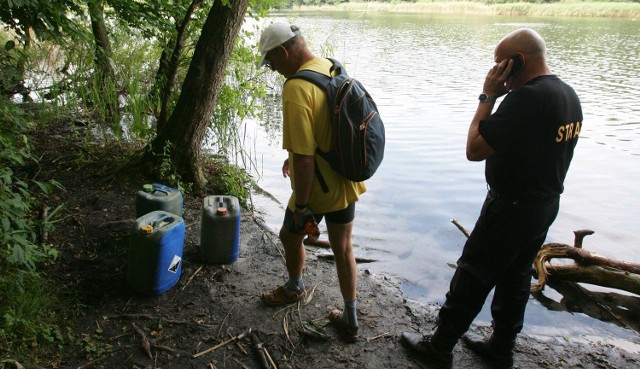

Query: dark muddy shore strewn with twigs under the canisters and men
left=26, top=121, right=640, bottom=369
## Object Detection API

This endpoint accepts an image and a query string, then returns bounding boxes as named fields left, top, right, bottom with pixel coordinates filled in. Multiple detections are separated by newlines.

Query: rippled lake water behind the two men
left=241, top=12, right=640, bottom=353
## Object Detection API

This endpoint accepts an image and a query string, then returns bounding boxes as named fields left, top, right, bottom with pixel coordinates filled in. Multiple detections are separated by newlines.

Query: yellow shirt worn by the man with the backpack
left=282, top=58, right=367, bottom=214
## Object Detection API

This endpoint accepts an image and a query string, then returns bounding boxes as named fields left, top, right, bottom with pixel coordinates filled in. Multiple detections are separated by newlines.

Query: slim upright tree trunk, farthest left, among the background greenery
left=88, top=0, right=120, bottom=128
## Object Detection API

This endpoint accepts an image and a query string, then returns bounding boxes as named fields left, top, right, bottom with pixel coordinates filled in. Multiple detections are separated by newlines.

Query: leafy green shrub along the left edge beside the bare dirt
left=0, top=98, right=62, bottom=358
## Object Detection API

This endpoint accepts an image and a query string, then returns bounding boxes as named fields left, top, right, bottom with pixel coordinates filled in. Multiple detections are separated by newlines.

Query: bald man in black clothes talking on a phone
left=402, top=28, right=582, bottom=368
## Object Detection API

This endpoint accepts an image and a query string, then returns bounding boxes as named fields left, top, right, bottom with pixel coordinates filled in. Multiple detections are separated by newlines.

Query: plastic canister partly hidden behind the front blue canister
left=136, top=183, right=183, bottom=218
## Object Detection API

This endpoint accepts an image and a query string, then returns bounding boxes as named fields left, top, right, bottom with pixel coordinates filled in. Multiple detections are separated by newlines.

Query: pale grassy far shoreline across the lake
left=282, top=0, right=640, bottom=20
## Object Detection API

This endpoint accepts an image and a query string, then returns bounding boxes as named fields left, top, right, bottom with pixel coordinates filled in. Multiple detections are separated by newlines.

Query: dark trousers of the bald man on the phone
left=438, top=191, right=560, bottom=348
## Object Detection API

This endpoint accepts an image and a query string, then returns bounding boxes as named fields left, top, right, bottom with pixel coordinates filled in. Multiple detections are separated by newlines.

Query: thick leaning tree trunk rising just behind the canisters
left=146, top=0, right=248, bottom=190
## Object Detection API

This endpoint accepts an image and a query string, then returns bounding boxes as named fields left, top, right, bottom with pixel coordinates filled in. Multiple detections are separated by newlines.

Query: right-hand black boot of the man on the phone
left=462, top=333, right=516, bottom=369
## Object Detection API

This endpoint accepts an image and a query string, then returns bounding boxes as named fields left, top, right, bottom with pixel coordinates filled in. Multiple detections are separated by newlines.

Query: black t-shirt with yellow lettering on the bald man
left=479, top=75, right=582, bottom=199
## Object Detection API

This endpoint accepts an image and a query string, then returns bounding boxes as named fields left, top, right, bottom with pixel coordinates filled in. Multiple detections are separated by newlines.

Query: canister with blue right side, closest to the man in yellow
left=200, top=196, right=240, bottom=264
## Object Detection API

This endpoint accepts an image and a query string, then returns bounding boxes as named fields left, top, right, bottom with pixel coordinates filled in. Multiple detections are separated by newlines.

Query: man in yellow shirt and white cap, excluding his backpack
left=259, top=23, right=366, bottom=342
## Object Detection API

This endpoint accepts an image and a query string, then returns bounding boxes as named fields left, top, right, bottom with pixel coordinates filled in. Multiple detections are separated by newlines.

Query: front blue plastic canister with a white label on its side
left=127, top=211, right=185, bottom=295
